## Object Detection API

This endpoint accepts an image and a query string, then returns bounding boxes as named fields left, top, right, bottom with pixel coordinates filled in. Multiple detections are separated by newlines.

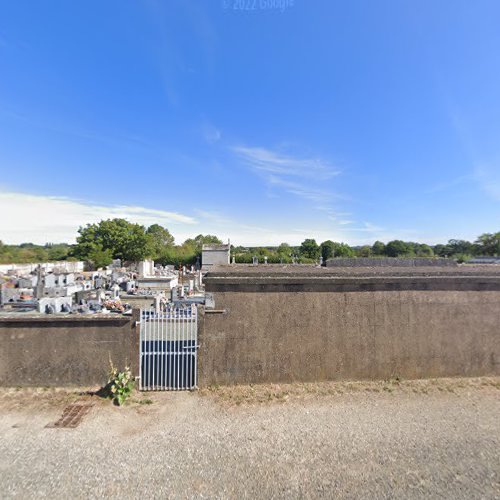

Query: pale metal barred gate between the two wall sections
left=139, top=304, right=198, bottom=391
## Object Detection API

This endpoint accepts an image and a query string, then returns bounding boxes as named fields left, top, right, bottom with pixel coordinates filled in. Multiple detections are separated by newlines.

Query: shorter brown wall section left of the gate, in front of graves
left=0, top=311, right=139, bottom=386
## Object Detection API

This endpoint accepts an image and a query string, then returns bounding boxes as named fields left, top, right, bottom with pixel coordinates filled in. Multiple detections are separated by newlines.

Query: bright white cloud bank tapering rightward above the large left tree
left=0, top=191, right=198, bottom=244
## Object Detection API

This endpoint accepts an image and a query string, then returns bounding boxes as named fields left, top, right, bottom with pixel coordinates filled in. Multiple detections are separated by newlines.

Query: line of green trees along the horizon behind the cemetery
left=0, top=219, right=500, bottom=268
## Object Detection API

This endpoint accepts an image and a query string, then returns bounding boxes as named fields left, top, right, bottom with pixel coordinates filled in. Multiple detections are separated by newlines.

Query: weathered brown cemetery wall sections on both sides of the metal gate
left=0, top=266, right=500, bottom=386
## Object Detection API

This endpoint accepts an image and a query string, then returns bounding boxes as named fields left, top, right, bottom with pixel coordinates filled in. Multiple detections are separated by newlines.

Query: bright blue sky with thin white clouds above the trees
left=0, top=0, right=500, bottom=245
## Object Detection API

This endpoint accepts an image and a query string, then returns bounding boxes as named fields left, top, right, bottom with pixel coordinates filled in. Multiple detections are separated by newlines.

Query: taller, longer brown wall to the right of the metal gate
left=199, top=266, right=500, bottom=385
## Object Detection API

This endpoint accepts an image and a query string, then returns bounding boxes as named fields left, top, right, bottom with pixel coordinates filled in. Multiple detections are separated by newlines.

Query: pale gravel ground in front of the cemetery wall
left=0, top=379, right=500, bottom=499
